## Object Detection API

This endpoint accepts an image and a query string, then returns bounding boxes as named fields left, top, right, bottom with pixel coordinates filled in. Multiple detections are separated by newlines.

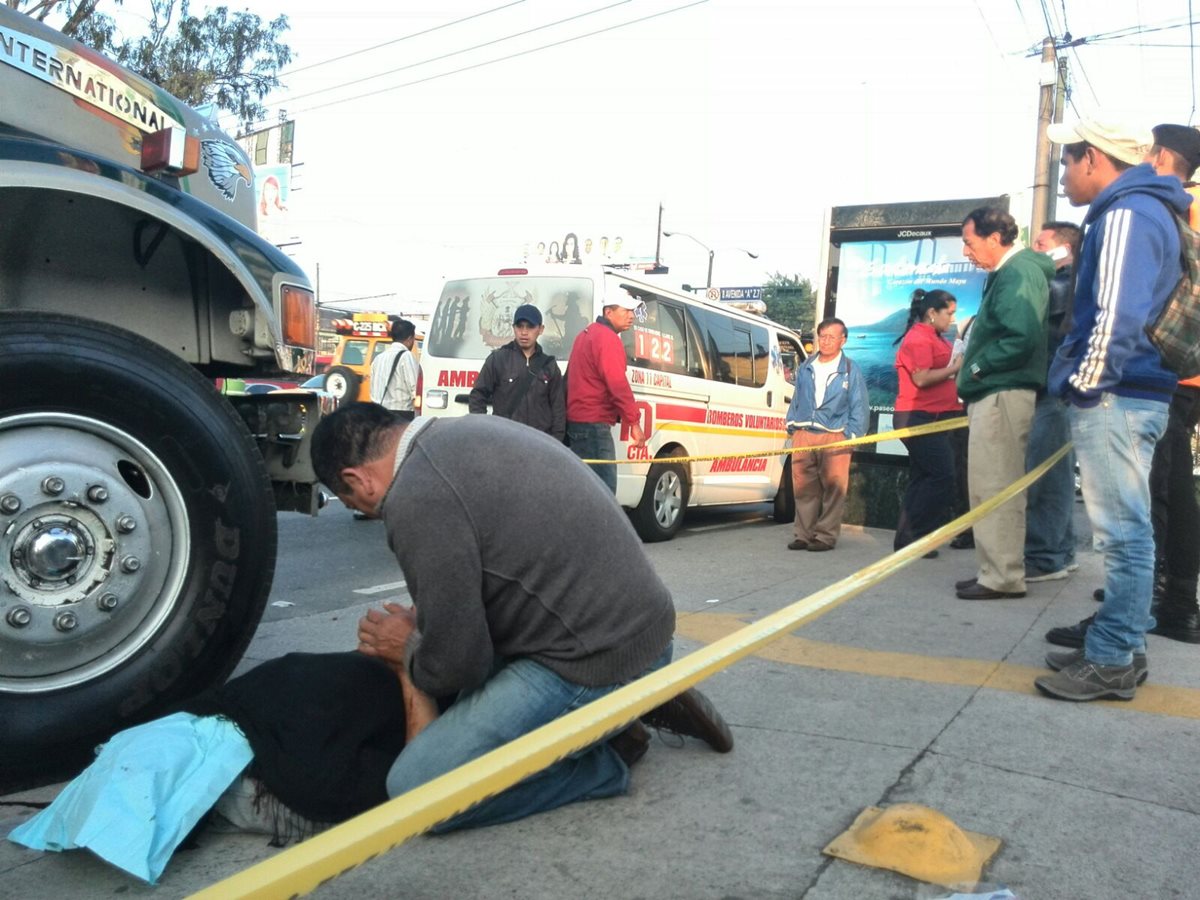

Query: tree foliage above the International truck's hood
left=5, top=0, right=292, bottom=125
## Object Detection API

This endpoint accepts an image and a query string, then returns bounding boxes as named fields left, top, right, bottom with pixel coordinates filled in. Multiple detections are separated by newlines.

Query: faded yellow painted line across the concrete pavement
left=676, top=612, right=1200, bottom=719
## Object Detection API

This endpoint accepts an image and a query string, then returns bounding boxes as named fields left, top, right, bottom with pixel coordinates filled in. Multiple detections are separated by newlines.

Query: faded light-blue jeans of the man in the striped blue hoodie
left=1068, top=394, right=1168, bottom=666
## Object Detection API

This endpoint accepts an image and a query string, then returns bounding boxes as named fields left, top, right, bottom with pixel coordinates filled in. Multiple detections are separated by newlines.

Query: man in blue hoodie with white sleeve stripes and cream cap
left=1034, top=119, right=1192, bottom=701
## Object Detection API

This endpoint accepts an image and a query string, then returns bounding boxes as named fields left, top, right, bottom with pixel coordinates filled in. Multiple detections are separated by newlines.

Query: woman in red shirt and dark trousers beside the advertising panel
left=892, top=288, right=962, bottom=558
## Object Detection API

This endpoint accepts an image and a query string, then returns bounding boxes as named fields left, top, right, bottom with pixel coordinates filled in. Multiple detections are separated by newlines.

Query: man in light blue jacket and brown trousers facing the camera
left=787, top=319, right=870, bottom=551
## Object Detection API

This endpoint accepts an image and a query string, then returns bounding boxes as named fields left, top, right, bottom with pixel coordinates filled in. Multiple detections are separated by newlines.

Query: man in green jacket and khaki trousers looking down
left=955, top=206, right=1055, bottom=600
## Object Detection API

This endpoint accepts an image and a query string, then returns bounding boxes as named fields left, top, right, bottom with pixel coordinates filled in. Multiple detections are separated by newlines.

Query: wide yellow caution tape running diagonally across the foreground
left=193, top=444, right=1072, bottom=900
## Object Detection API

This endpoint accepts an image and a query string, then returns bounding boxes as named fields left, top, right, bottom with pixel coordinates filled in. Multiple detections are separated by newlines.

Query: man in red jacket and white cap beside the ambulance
left=566, top=290, right=646, bottom=493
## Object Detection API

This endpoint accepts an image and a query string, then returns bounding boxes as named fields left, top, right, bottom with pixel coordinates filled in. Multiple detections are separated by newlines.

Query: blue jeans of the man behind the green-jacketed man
left=1025, top=394, right=1075, bottom=574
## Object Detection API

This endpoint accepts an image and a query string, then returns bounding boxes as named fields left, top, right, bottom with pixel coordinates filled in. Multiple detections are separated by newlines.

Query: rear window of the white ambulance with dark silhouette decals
left=426, top=275, right=593, bottom=361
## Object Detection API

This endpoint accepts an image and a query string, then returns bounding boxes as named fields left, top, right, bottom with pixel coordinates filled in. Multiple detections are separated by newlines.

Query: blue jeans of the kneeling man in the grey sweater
left=388, top=642, right=673, bottom=834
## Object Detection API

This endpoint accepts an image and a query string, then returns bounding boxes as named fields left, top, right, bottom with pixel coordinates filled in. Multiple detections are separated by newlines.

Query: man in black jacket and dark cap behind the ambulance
left=467, top=304, right=566, bottom=440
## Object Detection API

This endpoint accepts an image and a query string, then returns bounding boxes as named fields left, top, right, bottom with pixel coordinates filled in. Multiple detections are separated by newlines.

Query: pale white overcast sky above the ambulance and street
left=98, top=0, right=1200, bottom=314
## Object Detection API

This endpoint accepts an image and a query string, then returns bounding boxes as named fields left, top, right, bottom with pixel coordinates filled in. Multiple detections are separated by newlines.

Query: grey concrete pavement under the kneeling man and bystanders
left=0, top=517, right=1200, bottom=900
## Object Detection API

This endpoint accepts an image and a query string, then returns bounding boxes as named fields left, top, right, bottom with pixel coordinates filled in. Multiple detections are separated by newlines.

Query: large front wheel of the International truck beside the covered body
left=0, top=312, right=276, bottom=782
